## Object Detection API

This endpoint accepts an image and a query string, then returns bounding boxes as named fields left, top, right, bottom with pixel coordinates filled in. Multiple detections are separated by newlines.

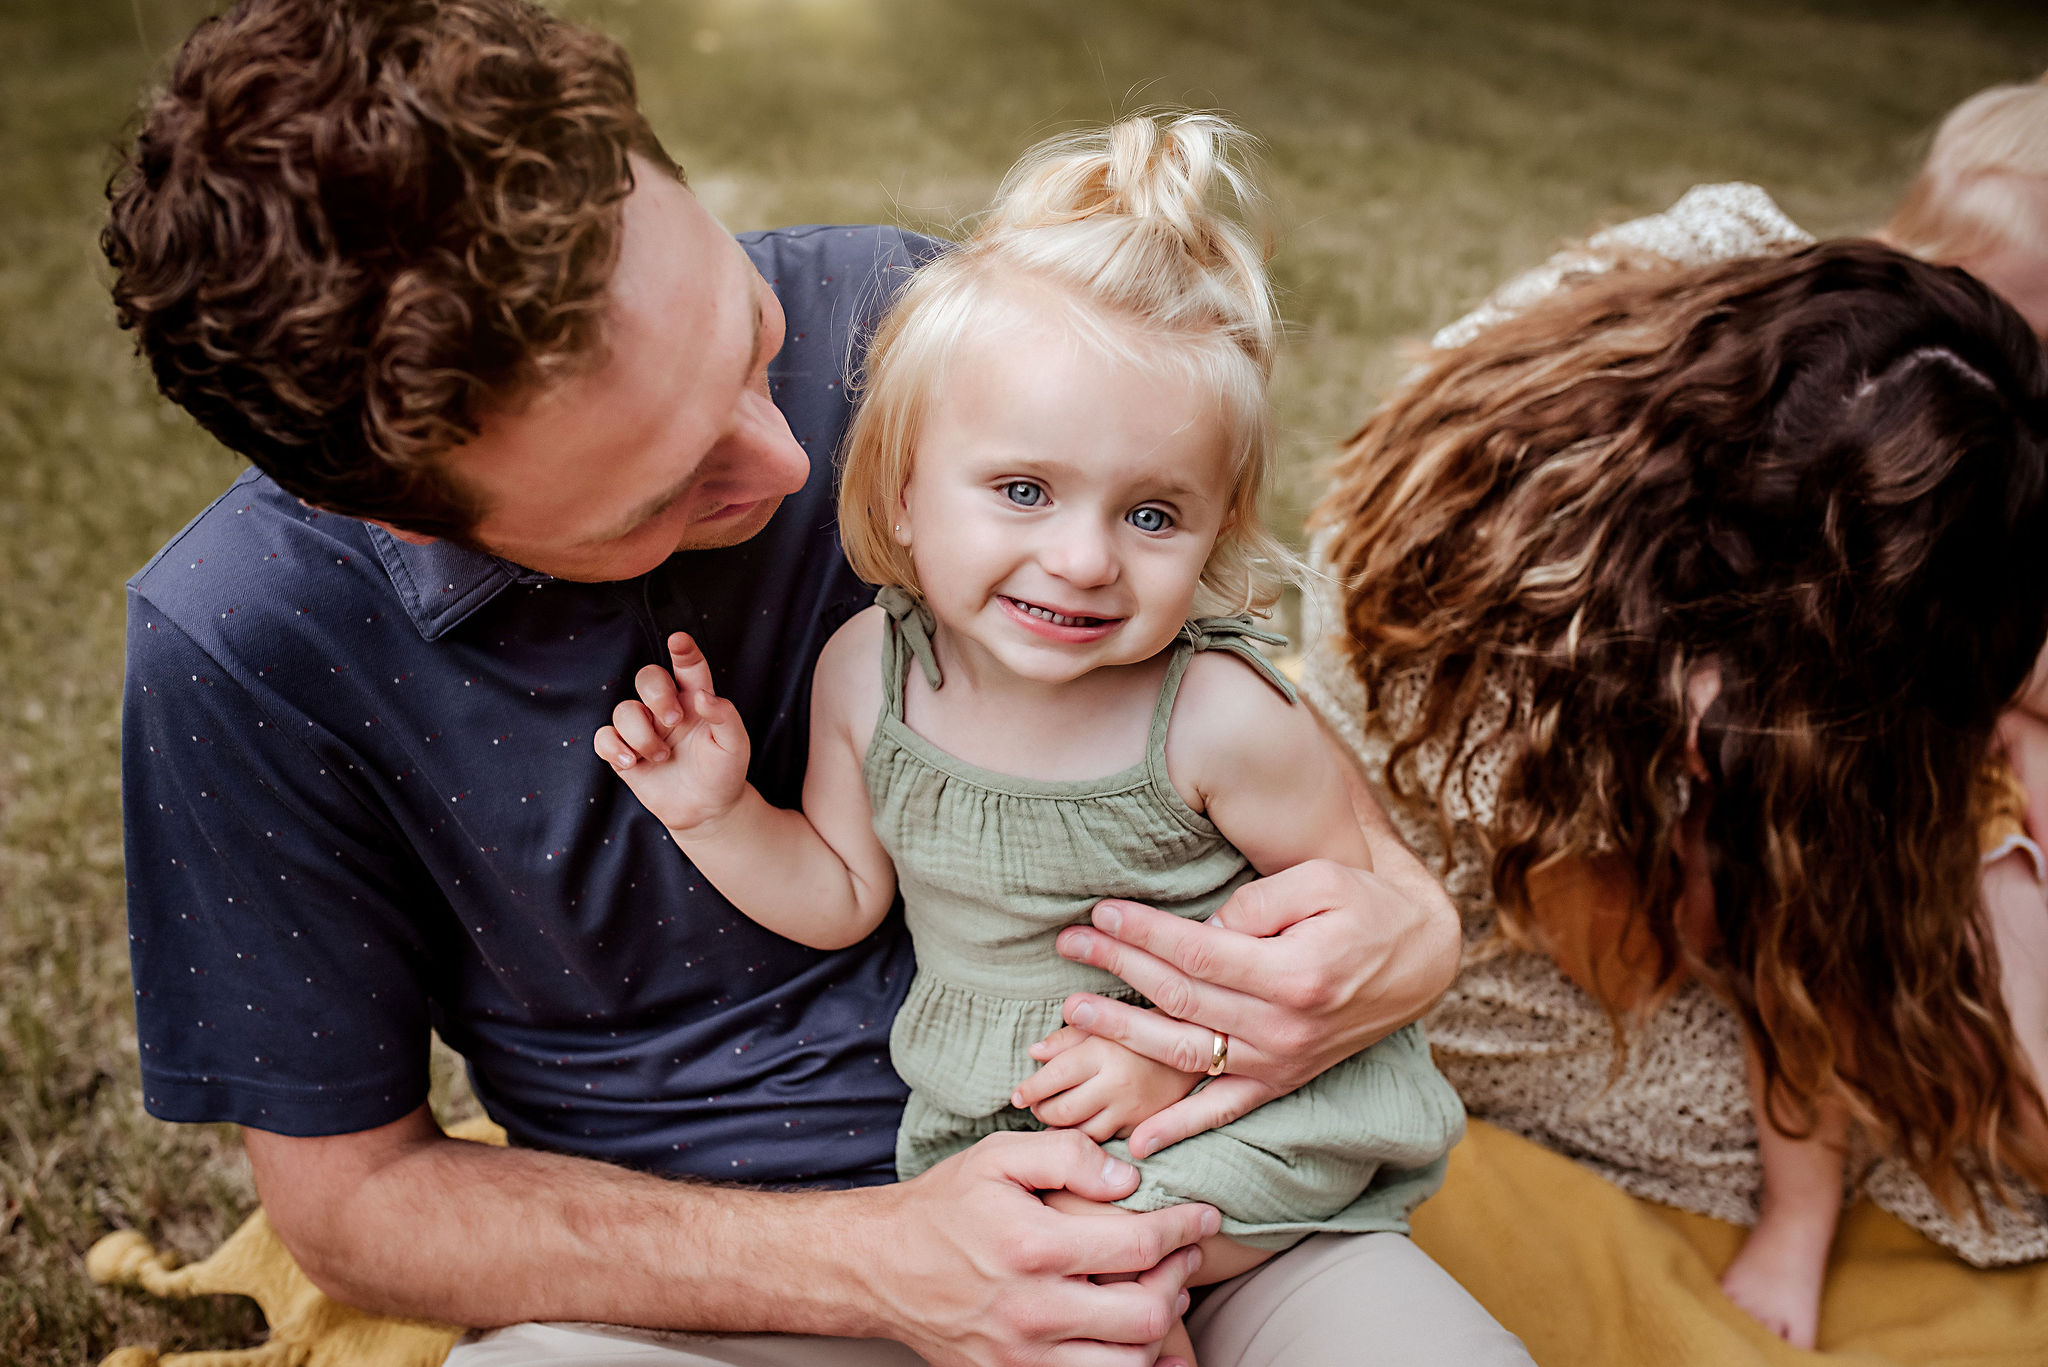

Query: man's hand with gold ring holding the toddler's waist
left=1059, top=856, right=1458, bottom=1158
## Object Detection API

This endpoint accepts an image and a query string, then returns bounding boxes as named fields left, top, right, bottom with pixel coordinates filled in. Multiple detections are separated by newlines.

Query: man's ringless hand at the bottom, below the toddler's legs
left=842, top=1129, right=1223, bottom=1367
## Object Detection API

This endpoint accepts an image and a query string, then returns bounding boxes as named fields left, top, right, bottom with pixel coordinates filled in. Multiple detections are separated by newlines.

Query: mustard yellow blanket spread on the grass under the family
left=86, top=1121, right=2048, bottom=1367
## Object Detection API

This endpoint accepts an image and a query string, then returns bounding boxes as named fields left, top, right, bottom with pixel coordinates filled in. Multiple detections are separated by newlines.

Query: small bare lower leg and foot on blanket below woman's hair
left=1720, top=1047, right=1849, bottom=1349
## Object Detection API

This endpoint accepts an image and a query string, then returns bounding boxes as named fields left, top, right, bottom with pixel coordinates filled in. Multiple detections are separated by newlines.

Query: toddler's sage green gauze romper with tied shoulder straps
left=862, top=588, right=1464, bottom=1248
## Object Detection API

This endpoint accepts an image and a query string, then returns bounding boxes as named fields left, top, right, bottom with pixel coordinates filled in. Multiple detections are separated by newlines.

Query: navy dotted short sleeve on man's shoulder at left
left=121, top=592, right=432, bottom=1135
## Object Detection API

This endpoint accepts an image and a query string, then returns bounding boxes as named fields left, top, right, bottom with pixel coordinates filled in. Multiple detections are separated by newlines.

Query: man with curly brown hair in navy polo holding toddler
left=102, top=0, right=1511, bottom=1363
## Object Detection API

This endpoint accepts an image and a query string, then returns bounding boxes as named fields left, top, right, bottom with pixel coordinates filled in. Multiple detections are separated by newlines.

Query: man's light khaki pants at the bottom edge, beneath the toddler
left=446, top=1234, right=1534, bottom=1367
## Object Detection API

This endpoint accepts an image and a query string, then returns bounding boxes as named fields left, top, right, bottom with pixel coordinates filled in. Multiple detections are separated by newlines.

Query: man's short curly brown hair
left=100, top=0, right=678, bottom=537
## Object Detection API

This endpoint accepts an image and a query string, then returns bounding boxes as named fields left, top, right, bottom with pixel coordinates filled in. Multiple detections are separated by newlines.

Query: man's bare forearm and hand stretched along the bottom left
left=242, top=1107, right=1219, bottom=1367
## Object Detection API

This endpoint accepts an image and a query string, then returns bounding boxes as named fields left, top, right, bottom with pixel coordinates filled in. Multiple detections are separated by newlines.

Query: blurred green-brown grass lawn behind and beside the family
left=0, top=0, right=2048, bottom=1367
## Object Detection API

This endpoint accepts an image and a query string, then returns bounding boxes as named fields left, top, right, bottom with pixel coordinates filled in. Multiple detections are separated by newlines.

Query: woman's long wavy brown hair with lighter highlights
left=1319, top=242, right=2048, bottom=1197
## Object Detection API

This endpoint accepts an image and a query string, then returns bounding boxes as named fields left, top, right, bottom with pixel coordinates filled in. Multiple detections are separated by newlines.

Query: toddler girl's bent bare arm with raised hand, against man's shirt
left=592, top=611, right=895, bottom=949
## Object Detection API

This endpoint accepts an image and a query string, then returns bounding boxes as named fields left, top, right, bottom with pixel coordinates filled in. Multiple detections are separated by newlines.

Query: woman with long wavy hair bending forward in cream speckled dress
left=1307, top=242, right=2048, bottom=1342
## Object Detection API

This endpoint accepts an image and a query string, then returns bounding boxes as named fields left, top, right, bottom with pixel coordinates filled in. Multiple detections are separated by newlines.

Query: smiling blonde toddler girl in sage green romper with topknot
left=594, top=115, right=1462, bottom=1361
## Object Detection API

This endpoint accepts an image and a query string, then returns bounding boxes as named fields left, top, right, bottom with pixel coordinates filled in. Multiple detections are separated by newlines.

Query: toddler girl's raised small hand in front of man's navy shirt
left=592, top=631, right=752, bottom=834
